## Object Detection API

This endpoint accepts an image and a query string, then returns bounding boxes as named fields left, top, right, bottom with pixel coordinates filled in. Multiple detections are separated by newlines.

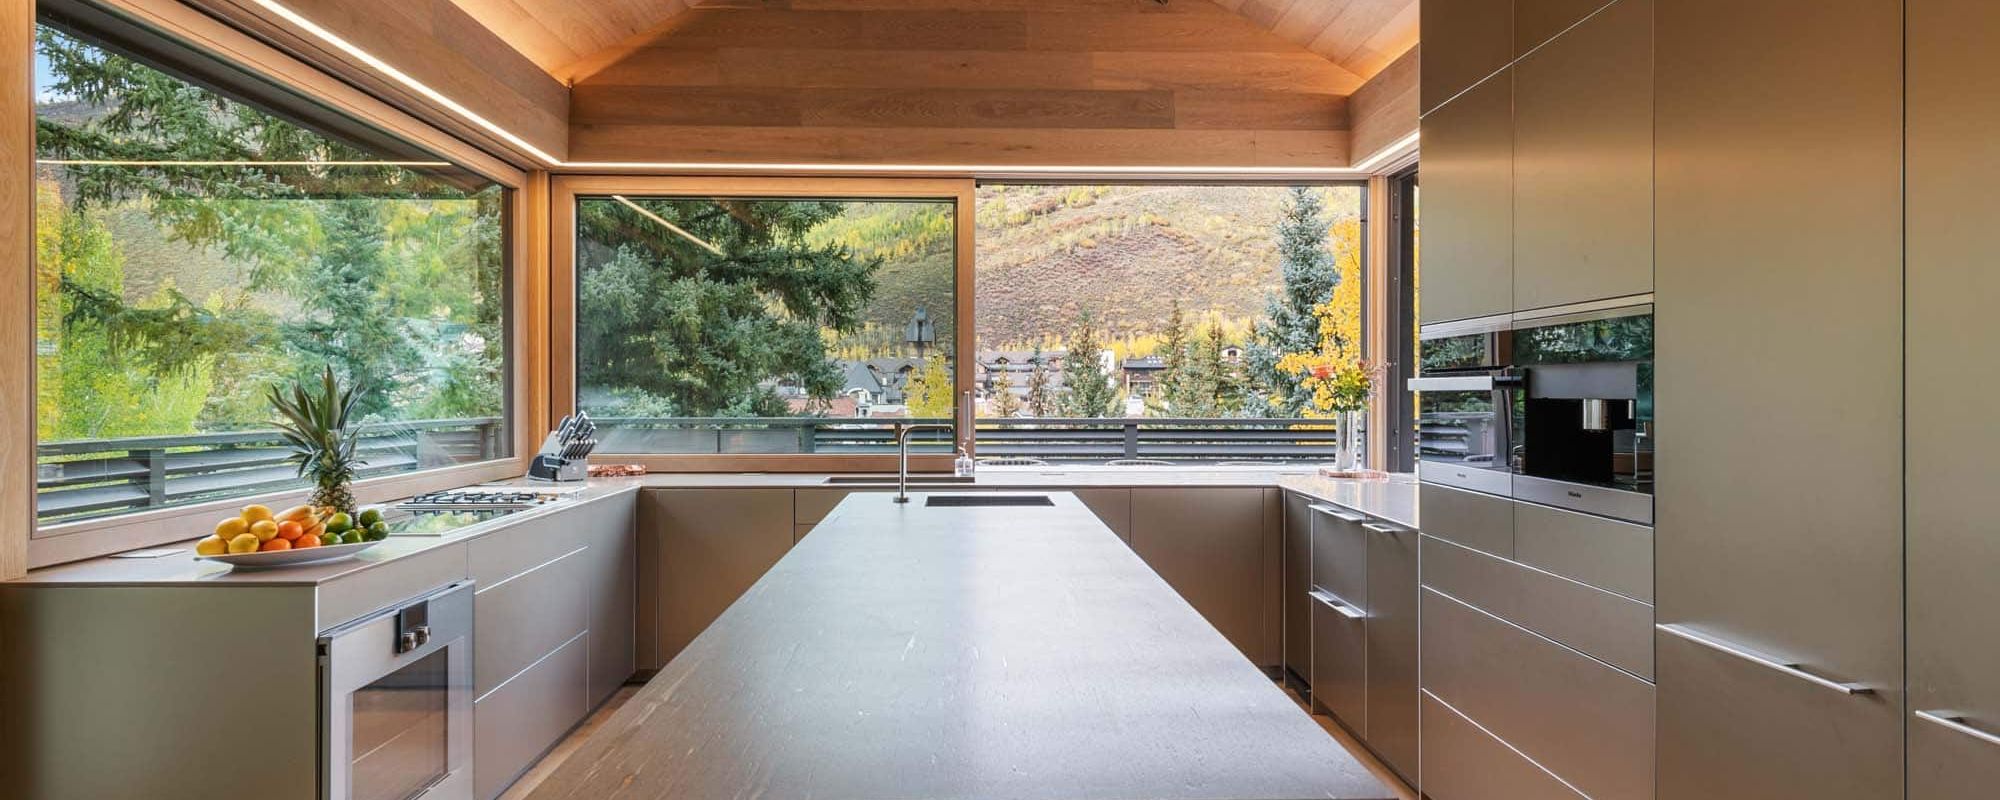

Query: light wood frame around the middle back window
left=544, top=174, right=978, bottom=472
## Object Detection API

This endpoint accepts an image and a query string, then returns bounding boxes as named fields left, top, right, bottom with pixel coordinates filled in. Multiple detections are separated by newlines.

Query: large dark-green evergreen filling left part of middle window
left=576, top=200, right=872, bottom=416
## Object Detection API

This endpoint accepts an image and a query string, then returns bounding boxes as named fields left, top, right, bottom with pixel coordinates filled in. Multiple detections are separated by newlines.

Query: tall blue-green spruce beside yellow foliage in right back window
left=1244, top=186, right=1340, bottom=416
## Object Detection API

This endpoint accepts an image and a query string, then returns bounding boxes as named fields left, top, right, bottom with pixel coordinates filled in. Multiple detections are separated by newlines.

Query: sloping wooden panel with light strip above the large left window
left=190, top=0, right=570, bottom=162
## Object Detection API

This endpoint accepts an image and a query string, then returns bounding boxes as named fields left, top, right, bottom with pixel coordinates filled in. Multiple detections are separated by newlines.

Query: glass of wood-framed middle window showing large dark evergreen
left=576, top=196, right=958, bottom=454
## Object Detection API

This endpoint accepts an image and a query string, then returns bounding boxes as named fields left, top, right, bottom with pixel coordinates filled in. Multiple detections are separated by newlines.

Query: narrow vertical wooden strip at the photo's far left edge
left=0, top=0, right=34, bottom=580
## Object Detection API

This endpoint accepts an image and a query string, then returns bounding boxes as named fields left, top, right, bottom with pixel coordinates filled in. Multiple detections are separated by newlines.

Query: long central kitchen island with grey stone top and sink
left=532, top=492, right=1392, bottom=800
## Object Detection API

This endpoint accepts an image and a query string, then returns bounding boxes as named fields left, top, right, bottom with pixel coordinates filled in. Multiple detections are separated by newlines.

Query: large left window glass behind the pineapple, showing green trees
left=34, top=20, right=510, bottom=522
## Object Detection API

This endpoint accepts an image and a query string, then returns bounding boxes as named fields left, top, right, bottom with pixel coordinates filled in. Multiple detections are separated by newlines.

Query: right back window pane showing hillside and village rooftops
left=974, top=184, right=1372, bottom=464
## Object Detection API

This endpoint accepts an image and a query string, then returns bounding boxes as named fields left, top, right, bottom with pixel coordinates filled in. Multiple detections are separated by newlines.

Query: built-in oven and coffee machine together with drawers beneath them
left=1410, top=302, right=1656, bottom=798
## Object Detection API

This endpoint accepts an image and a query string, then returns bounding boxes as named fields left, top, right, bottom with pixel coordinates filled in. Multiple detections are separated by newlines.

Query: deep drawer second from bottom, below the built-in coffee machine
left=1422, top=588, right=1654, bottom=800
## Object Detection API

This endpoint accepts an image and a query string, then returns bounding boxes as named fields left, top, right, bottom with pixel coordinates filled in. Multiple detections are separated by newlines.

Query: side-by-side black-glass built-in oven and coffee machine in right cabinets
left=1410, top=306, right=1656, bottom=524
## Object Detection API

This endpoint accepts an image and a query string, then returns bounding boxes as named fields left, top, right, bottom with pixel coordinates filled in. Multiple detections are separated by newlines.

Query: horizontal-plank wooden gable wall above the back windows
left=570, top=0, right=1362, bottom=168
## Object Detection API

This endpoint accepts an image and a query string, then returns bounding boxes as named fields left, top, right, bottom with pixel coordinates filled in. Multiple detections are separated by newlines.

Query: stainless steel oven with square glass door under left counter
left=318, top=582, right=472, bottom=800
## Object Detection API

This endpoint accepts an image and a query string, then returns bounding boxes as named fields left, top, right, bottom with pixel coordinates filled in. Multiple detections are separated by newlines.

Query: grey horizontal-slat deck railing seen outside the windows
left=36, top=416, right=1338, bottom=520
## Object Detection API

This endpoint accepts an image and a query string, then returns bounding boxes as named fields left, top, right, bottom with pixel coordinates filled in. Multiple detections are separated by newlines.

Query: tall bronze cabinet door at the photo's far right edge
left=1904, top=0, right=2000, bottom=800
